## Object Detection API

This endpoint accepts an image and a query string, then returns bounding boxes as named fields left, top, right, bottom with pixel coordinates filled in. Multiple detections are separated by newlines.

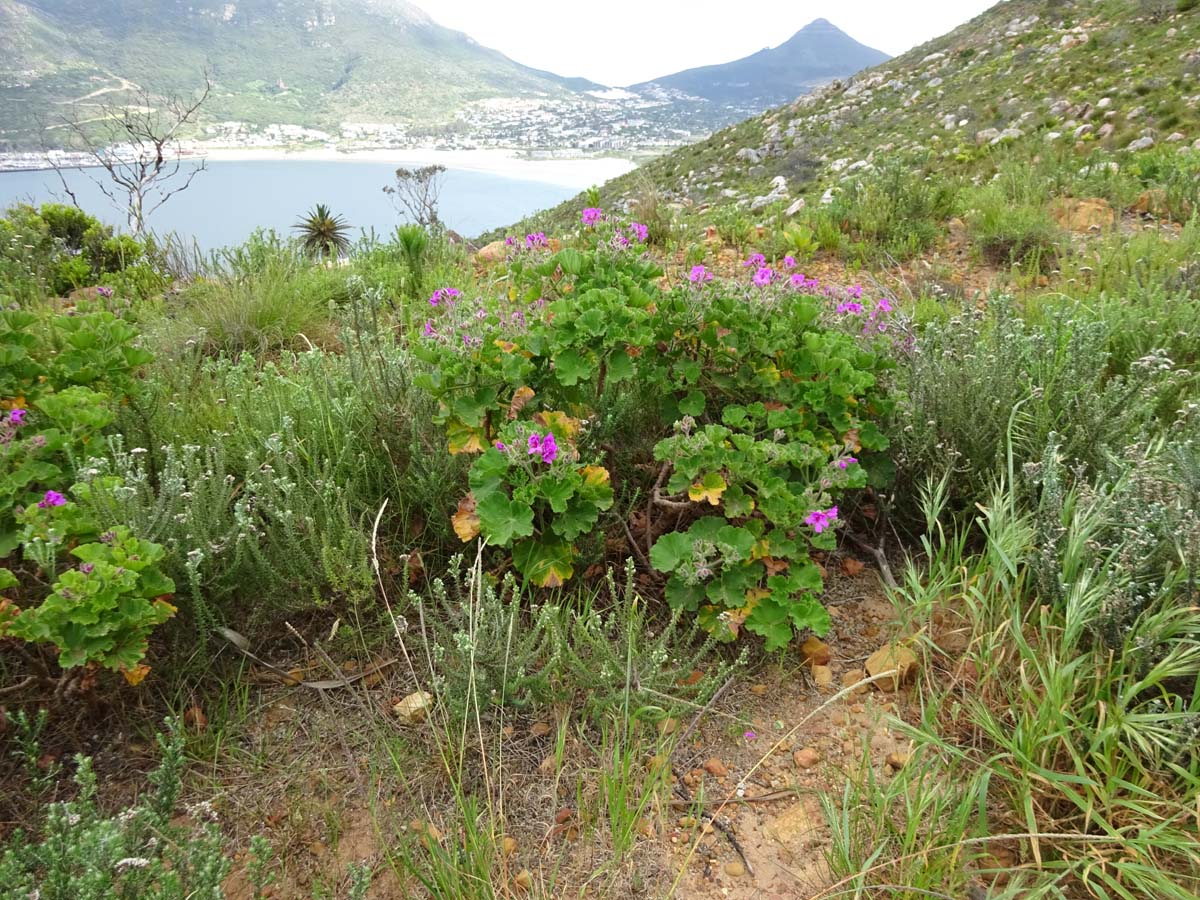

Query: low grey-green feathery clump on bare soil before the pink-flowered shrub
left=408, top=556, right=744, bottom=720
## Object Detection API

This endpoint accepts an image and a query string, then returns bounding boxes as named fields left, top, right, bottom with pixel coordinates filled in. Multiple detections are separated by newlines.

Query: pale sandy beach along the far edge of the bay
left=0, top=148, right=636, bottom=190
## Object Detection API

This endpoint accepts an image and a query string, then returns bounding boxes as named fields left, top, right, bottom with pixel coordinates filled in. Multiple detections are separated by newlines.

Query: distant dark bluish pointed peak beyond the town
left=632, top=19, right=889, bottom=112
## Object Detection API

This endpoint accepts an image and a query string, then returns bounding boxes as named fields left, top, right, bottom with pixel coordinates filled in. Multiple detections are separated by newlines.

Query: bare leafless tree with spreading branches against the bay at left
left=43, top=72, right=212, bottom=235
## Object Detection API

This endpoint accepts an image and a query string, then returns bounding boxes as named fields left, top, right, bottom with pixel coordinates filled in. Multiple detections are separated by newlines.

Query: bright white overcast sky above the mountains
left=427, top=0, right=995, bottom=85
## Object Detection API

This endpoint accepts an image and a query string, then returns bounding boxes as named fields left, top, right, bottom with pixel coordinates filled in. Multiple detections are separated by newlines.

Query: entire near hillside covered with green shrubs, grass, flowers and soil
left=7, top=0, right=1200, bottom=900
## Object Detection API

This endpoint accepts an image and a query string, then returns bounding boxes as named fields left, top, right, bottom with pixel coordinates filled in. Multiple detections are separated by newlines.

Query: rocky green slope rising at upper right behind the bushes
left=515, top=0, right=1200, bottom=240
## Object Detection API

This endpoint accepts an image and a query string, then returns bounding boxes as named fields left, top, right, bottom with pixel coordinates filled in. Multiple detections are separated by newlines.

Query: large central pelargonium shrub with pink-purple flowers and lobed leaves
left=414, top=209, right=890, bottom=648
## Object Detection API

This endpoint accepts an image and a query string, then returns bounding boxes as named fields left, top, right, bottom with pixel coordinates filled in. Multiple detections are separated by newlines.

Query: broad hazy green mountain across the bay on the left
left=0, top=0, right=600, bottom=150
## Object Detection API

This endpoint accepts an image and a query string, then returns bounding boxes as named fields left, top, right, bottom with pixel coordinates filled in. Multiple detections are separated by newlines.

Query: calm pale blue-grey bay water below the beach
left=0, top=160, right=590, bottom=251
